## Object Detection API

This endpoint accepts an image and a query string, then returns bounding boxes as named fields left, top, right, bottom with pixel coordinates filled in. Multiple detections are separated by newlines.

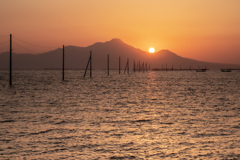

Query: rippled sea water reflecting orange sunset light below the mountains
left=0, top=70, right=240, bottom=159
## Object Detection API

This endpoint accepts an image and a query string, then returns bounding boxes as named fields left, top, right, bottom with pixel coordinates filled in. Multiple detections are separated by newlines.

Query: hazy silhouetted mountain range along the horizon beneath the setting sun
left=0, top=39, right=240, bottom=69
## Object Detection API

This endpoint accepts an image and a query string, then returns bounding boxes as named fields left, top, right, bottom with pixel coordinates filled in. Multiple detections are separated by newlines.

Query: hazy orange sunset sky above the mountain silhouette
left=0, top=0, right=240, bottom=64
